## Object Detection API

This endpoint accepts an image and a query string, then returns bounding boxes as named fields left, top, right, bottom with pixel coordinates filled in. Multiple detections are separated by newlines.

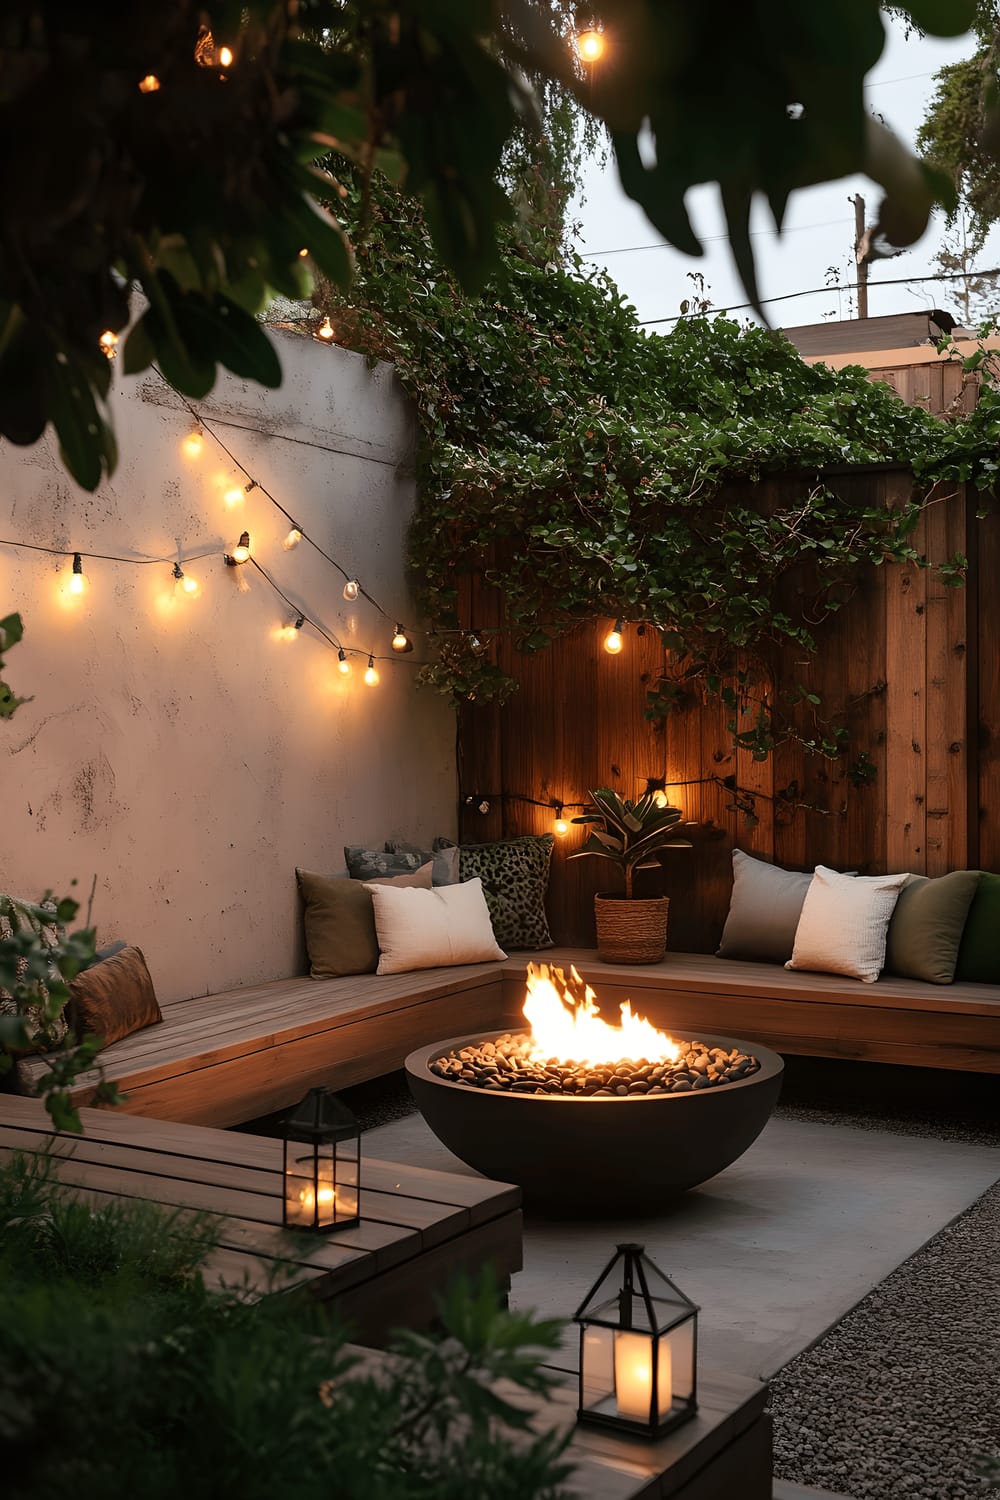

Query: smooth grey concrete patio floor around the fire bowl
left=363, top=1115, right=1000, bottom=1379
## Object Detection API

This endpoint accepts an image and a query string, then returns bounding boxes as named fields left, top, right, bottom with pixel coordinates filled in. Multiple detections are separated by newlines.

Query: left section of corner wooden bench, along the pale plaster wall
left=16, top=963, right=521, bottom=1125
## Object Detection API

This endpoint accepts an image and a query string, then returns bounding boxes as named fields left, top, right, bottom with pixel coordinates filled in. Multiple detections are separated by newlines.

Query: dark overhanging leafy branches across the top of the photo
left=0, top=0, right=975, bottom=489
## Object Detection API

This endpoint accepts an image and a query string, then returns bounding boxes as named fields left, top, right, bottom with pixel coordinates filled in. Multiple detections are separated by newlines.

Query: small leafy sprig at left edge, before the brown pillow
left=0, top=891, right=120, bottom=1133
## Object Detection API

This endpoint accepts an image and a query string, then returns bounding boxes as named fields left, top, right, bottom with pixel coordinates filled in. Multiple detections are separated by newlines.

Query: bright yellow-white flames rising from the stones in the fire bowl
left=523, top=963, right=681, bottom=1062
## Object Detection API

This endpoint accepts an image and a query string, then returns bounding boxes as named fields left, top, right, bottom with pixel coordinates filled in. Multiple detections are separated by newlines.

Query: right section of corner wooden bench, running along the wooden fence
left=504, top=948, right=1000, bottom=1073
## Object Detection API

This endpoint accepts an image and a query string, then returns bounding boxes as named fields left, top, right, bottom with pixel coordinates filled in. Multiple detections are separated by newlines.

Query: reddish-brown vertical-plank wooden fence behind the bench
left=459, top=467, right=1000, bottom=951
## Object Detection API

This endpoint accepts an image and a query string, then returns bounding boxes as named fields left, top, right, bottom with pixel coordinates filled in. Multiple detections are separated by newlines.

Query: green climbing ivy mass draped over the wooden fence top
left=322, top=168, right=1000, bottom=755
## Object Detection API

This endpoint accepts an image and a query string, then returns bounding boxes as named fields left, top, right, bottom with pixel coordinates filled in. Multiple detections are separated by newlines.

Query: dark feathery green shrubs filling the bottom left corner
left=0, top=1158, right=568, bottom=1500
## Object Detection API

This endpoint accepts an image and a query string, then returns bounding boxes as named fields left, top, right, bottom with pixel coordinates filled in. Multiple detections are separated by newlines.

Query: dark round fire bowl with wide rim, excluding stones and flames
left=406, top=1032, right=784, bottom=1218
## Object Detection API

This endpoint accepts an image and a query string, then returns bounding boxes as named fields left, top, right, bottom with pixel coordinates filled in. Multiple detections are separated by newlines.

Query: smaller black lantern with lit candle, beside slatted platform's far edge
left=282, top=1089, right=361, bottom=1233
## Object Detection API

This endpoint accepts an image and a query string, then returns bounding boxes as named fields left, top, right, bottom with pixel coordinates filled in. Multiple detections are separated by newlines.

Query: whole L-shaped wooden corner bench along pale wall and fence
left=18, top=948, right=1000, bottom=1125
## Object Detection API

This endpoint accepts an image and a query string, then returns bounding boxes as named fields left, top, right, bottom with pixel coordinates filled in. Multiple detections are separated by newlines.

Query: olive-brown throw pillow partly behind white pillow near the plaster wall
left=295, top=861, right=430, bottom=980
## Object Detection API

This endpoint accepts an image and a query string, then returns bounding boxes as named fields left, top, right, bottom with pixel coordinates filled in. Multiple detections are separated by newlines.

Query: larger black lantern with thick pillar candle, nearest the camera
left=574, top=1245, right=699, bottom=1437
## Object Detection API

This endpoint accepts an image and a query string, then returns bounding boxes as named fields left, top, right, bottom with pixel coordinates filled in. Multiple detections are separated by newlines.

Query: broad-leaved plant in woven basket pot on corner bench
left=570, top=786, right=691, bottom=963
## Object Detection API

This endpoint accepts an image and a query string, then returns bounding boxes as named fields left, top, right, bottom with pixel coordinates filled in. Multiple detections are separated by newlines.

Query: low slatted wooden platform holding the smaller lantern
left=0, top=1097, right=522, bottom=1344
